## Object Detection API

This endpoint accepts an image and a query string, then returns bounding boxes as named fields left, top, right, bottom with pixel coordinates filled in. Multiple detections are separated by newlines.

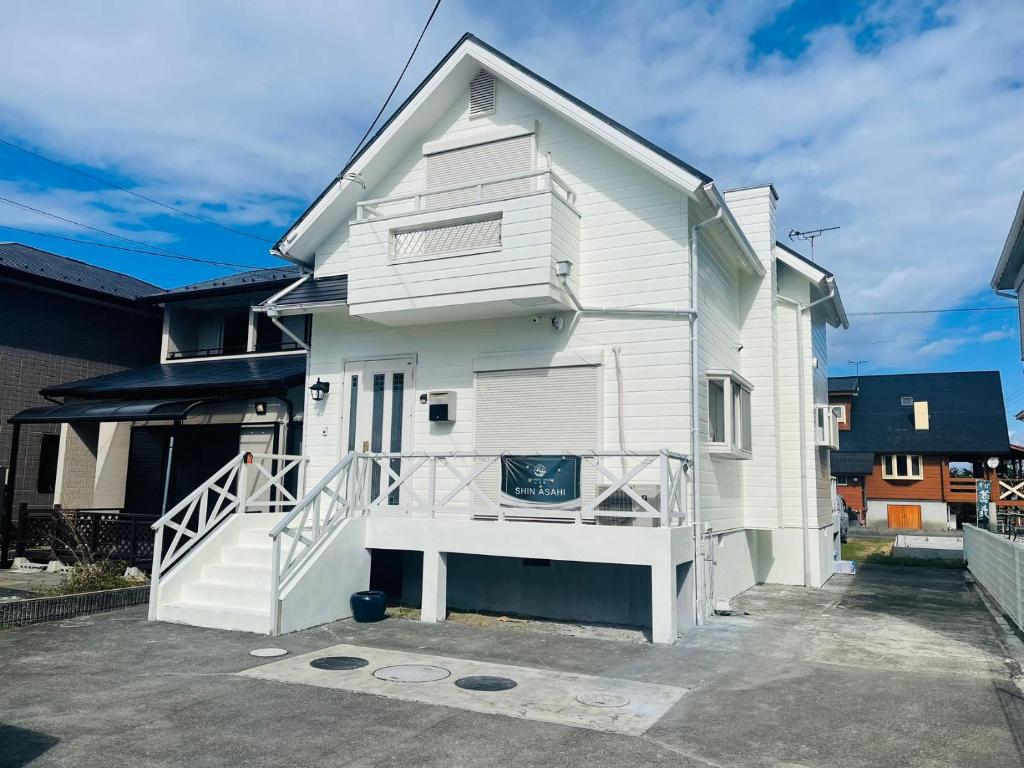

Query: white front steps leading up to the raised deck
left=160, top=514, right=283, bottom=634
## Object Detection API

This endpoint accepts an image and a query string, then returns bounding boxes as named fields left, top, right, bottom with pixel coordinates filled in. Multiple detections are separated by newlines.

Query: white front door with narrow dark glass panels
left=342, top=357, right=416, bottom=504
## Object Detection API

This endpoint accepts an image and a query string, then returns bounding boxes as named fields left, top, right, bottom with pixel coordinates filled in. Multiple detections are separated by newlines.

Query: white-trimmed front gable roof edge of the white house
left=271, top=33, right=763, bottom=274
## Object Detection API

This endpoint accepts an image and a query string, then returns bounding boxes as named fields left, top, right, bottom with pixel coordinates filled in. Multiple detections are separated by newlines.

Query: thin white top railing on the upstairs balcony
left=355, top=170, right=575, bottom=221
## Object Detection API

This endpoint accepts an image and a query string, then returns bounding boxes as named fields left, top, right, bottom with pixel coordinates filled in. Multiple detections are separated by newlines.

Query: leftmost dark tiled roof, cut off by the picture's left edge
left=0, top=243, right=160, bottom=301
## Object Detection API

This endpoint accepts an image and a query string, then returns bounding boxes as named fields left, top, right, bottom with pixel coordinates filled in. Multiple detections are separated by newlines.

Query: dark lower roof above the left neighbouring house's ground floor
left=43, top=354, right=306, bottom=397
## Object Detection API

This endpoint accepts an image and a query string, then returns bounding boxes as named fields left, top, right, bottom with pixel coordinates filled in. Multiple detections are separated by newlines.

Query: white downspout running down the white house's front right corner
left=689, top=199, right=725, bottom=627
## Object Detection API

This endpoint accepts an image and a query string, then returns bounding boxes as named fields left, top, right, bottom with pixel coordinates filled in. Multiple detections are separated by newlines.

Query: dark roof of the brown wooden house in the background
left=828, top=371, right=1010, bottom=455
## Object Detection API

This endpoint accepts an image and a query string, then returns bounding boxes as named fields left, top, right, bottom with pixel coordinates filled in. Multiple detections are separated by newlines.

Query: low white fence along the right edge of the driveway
left=964, top=524, right=1024, bottom=627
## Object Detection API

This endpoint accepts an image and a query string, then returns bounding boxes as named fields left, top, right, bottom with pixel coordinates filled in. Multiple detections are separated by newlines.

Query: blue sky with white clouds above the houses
left=6, top=0, right=1024, bottom=442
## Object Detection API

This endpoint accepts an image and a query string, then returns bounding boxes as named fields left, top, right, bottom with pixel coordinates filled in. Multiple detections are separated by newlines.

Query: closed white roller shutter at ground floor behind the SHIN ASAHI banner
left=476, top=366, right=601, bottom=512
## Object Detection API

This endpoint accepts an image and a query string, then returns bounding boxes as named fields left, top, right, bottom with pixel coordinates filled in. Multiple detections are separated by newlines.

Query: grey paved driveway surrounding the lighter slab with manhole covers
left=0, top=566, right=1024, bottom=768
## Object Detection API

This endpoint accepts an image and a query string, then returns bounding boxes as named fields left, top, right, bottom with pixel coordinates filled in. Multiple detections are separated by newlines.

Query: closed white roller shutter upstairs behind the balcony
left=426, top=134, right=536, bottom=208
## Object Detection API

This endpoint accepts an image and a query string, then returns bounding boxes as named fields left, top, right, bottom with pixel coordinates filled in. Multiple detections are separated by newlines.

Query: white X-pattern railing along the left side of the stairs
left=151, top=453, right=307, bottom=604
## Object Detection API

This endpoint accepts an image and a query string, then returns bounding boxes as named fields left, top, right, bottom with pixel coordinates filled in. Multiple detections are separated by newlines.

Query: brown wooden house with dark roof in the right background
left=828, top=371, right=1024, bottom=530
